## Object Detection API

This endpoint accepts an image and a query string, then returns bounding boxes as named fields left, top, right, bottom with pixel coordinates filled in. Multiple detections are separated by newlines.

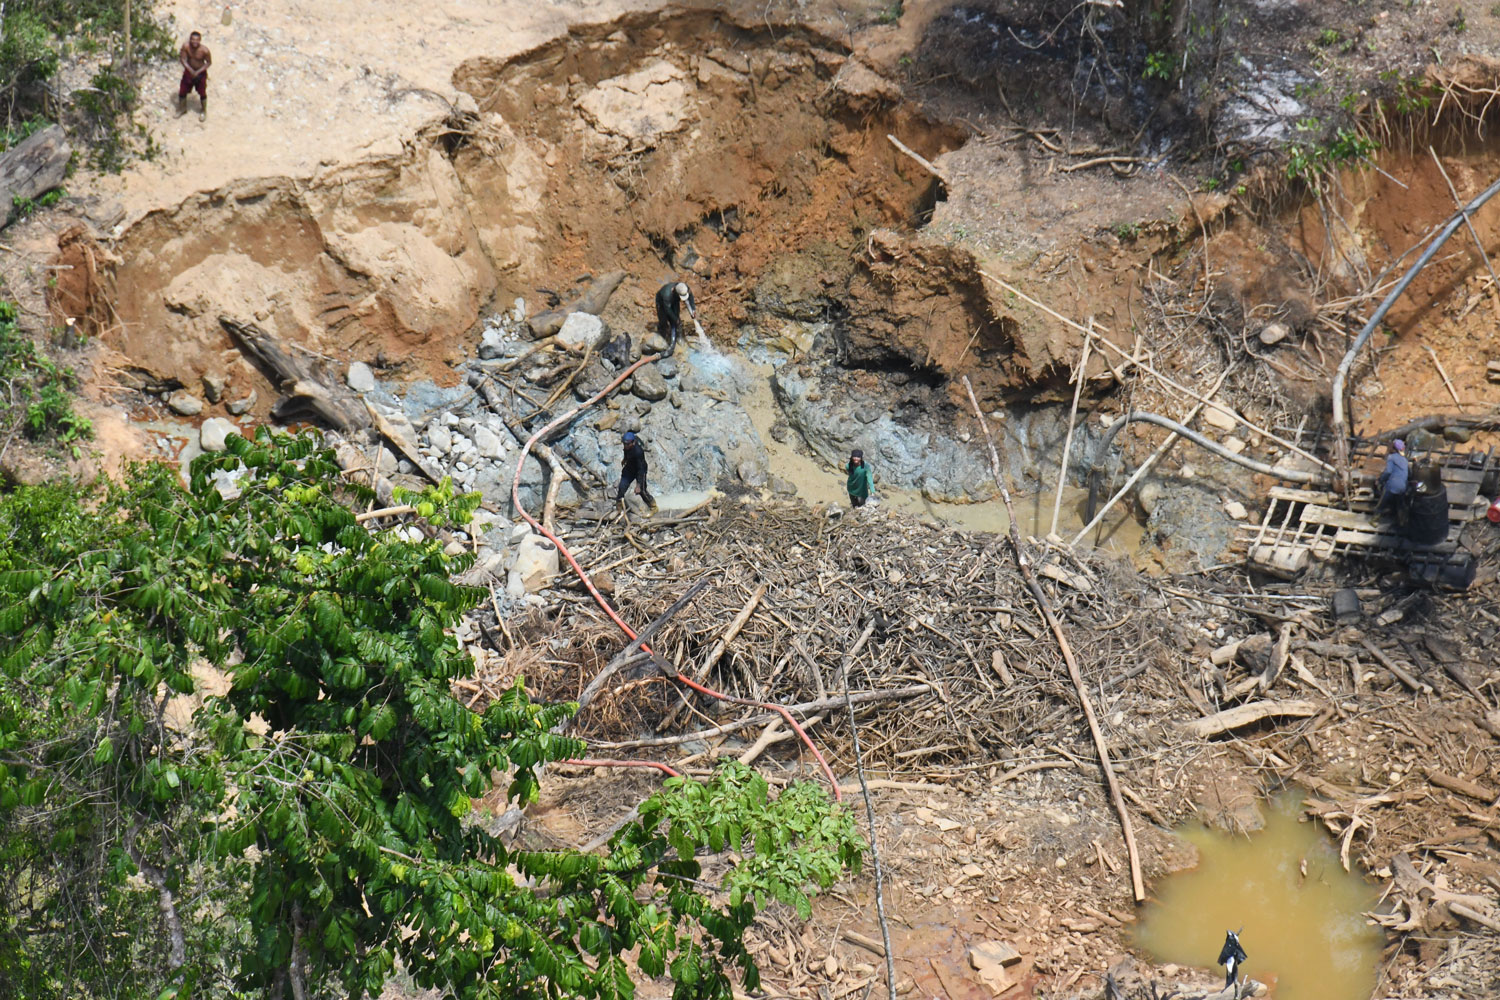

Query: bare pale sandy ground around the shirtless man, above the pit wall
left=69, top=0, right=659, bottom=232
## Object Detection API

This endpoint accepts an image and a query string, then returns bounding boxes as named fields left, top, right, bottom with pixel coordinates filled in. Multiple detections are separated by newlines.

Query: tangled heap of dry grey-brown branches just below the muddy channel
left=468, top=502, right=1176, bottom=772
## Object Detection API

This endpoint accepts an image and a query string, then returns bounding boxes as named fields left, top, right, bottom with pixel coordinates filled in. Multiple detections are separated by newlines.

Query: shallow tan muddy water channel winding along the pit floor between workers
left=740, top=363, right=1145, bottom=559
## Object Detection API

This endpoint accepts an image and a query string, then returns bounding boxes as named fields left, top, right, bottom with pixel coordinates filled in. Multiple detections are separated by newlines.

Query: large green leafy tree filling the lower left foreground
left=0, top=429, right=863, bottom=1000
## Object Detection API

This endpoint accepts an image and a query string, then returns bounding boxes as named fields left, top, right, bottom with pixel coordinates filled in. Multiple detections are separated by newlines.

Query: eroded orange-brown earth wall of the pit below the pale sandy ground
left=82, top=5, right=1052, bottom=408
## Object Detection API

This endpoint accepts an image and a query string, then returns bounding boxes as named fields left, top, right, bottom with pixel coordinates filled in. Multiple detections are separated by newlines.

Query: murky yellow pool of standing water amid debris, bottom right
left=1136, top=796, right=1382, bottom=1000
